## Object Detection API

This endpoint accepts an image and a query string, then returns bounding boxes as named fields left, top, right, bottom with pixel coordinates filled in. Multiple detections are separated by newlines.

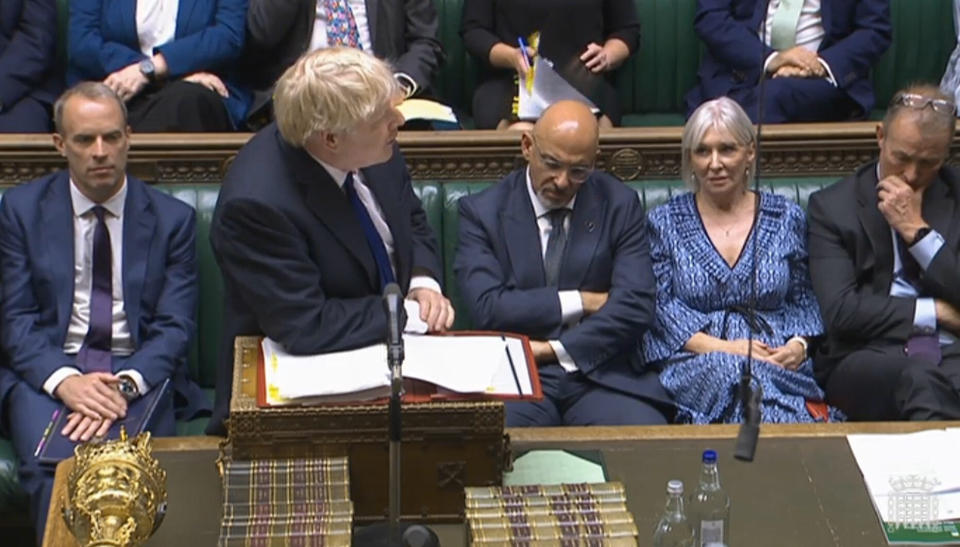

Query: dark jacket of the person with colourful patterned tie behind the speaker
left=247, top=0, right=443, bottom=110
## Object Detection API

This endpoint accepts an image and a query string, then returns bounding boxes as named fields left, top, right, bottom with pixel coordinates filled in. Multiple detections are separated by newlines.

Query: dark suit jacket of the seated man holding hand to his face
left=807, top=163, right=960, bottom=382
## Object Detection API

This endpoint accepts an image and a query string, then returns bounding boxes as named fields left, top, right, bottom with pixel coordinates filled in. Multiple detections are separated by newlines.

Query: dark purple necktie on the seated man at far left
left=77, top=205, right=113, bottom=372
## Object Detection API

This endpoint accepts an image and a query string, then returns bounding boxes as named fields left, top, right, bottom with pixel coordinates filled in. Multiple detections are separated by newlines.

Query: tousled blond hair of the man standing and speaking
left=273, top=47, right=400, bottom=147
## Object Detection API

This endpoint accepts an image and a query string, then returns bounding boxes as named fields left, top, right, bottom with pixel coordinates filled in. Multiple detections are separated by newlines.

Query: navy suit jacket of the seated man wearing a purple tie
left=0, top=171, right=209, bottom=430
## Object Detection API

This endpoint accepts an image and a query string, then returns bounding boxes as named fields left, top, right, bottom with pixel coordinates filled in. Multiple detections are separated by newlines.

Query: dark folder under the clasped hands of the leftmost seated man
left=37, top=378, right=170, bottom=465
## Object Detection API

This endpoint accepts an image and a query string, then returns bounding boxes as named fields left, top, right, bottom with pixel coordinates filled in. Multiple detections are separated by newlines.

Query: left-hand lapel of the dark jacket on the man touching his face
left=857, top=163, right=893, bottom=291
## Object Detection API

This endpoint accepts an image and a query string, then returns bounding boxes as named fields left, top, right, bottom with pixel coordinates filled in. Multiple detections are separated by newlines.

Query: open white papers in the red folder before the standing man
left=261, top=334, right=534, bottom=405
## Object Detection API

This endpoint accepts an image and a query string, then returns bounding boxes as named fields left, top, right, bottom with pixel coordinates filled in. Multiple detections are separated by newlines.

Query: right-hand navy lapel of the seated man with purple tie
left=122, top=176, right=157, bottom=346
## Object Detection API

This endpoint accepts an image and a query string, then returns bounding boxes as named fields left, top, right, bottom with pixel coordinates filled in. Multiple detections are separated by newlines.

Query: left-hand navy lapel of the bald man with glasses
left=500, top=176, right=546, bottom=289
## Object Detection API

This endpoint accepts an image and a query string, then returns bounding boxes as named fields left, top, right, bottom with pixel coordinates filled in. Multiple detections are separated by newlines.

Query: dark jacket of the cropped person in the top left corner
left=0, top=0, right=60, bottom=111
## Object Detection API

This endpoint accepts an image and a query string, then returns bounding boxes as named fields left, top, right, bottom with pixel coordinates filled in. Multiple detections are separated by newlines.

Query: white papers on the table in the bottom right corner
left=847, top=428, right=960, bottom=545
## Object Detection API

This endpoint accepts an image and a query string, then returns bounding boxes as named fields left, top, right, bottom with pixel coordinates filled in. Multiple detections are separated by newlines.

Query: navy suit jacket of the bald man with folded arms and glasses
left=454, top=169, right=670, bottom=403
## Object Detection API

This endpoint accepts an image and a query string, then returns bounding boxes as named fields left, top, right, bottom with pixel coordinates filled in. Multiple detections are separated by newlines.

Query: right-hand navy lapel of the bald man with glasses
left=560, top=180, right=606, bottom=289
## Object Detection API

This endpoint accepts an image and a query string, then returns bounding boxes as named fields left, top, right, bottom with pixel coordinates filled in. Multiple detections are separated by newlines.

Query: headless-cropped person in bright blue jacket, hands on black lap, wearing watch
left=67, top=0, right=250, bottom=132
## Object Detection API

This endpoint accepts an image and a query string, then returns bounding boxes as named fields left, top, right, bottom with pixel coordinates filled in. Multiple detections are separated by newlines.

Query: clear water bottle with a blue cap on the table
left=690, top=450, right=730, bottom=547
